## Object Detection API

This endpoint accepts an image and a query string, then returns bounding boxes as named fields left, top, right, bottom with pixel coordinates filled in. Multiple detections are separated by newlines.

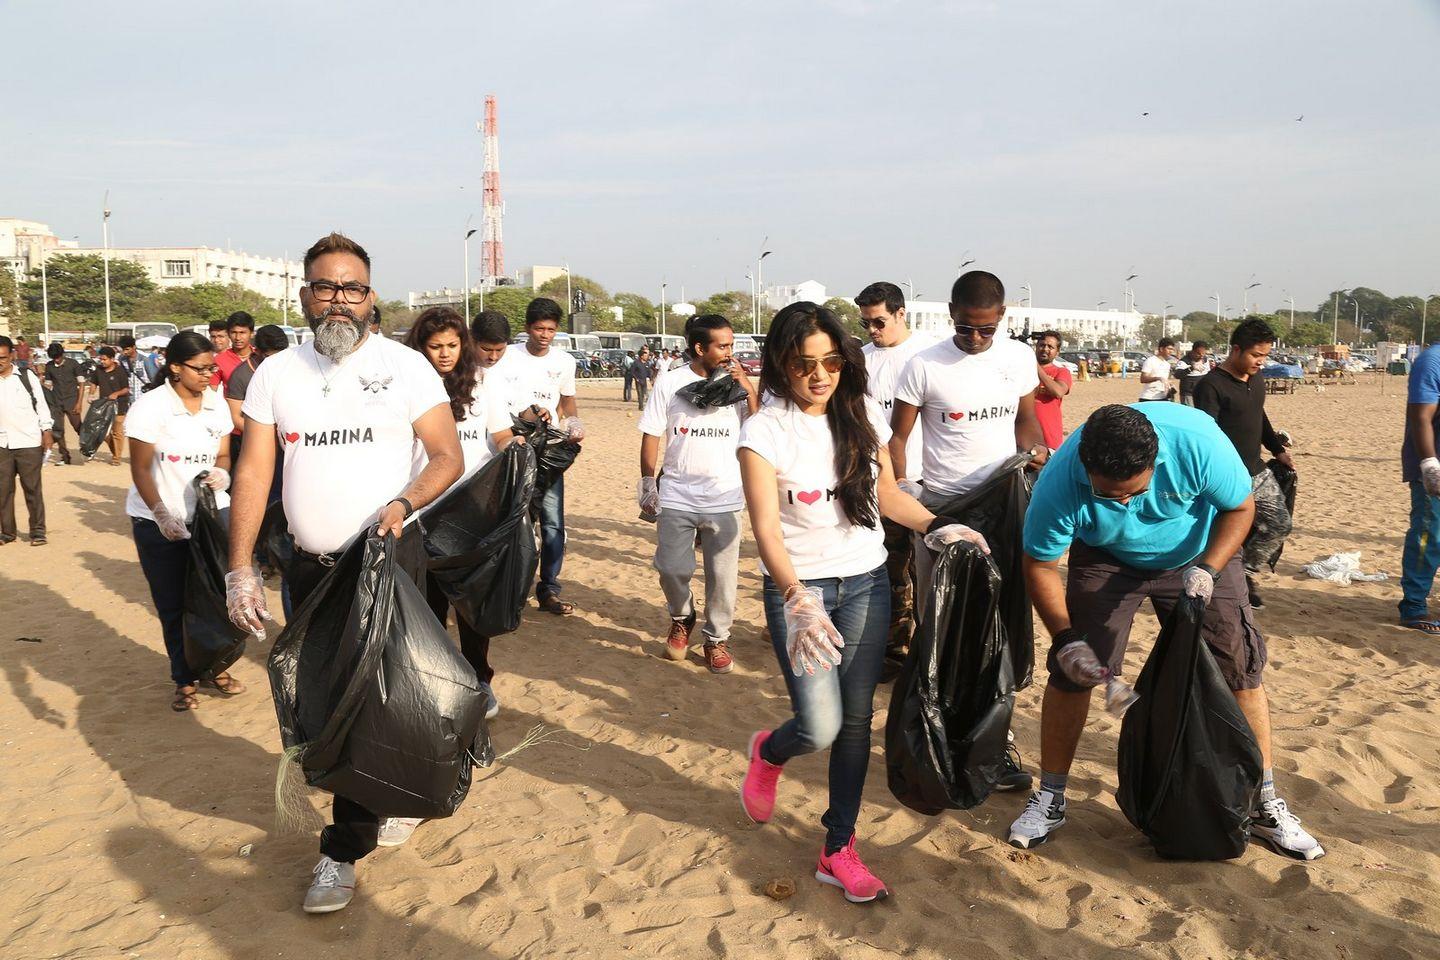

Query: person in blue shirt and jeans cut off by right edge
left=1400, top=344, right=1440, bottom=636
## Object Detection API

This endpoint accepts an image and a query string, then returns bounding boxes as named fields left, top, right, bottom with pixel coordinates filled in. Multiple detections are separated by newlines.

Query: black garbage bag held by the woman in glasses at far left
left=181, top=474, right=248, bottom=679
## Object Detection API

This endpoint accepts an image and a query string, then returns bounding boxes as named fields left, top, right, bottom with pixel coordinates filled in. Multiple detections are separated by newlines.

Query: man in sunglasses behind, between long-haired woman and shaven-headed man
left=855, top=281, right=935, bottom=684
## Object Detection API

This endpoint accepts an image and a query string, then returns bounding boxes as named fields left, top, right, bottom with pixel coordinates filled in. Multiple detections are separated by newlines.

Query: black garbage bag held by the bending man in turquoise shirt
left=1116, top=603, right=1261, bottom=861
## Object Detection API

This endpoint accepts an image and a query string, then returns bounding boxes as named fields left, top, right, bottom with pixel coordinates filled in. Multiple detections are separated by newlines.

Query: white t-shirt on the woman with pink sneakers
left=740, top=400, right=890, bottom=580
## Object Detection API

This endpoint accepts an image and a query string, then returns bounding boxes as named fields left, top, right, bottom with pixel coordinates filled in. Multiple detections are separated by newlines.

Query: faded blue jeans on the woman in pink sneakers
left=762, top=564, right=890, bottom=851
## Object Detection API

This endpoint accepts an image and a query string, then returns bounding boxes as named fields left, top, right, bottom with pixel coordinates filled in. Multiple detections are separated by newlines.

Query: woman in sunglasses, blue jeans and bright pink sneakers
left=740, top=302, right=984, bottom=902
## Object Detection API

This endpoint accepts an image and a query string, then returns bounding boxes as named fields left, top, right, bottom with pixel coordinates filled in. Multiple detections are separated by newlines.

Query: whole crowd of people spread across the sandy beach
left=0, top=235, right=1370, bottom=913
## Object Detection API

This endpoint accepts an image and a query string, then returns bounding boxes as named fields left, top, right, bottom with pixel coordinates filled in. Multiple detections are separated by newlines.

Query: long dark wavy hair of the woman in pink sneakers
left=760, top=301, right=880, bottom=527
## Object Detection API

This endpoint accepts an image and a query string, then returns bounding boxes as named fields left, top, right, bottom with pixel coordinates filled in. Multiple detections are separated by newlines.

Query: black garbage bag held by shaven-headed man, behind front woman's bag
left=935, top=453, right=1035, bottom=689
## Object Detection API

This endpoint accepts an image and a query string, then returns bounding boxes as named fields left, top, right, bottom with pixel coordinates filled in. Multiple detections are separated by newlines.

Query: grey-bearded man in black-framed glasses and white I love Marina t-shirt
left=225, top=233, right=462, bottom=914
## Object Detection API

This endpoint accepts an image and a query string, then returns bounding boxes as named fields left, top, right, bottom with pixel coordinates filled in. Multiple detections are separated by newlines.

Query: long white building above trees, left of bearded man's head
left=52, top=246, right=305, bottom=307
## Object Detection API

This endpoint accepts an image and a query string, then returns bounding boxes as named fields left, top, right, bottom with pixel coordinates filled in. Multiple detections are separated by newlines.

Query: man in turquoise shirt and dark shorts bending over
left=1009, top=403, right=1325, bottom=861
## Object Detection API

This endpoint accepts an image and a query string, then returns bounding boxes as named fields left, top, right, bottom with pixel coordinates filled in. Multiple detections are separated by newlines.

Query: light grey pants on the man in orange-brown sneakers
left=655, top=507, right=740, bottom=643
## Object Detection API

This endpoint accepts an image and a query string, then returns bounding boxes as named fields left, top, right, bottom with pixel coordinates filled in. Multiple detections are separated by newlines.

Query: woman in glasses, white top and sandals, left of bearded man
left=125, top=331, right=236, bottom=712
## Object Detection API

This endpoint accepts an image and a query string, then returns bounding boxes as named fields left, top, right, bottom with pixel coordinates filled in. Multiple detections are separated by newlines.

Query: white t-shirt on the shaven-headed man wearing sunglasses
left=896, top=335, right=1040, bottom=494
